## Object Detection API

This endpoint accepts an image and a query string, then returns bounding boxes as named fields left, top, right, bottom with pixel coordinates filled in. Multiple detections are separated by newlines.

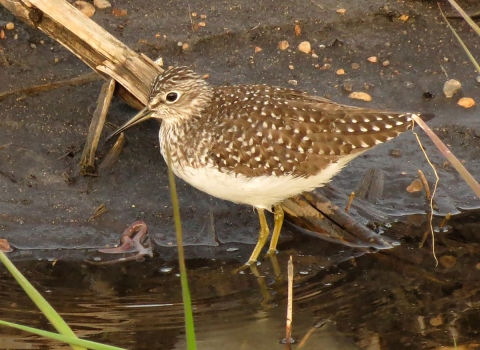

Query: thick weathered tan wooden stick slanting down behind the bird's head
left=0, top=0, right=162, bottom=109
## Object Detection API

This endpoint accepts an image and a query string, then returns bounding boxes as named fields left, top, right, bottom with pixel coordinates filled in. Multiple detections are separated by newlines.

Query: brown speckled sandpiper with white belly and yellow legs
left=110, top=67, right=432, bottom=267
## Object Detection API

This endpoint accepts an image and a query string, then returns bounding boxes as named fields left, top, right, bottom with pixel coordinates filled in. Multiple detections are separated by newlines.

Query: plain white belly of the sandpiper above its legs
left=169, top=154, right=358, bottom=210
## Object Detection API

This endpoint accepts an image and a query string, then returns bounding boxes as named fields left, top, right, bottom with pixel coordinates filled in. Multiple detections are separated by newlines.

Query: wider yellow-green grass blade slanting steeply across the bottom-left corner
left=0, top=251, right=84, bottom=350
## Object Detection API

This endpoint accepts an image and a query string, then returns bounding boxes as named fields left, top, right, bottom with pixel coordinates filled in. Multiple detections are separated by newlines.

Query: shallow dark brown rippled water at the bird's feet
left=0, top=213, right=480, bottom=349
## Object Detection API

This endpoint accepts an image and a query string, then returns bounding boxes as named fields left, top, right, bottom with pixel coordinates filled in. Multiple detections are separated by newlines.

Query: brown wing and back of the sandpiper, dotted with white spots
left=205, top=85, right=422, bottom=177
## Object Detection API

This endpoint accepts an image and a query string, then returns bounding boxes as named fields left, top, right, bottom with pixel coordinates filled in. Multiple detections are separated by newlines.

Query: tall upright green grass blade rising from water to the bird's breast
left=167, top=144, right=197, bottom=350
